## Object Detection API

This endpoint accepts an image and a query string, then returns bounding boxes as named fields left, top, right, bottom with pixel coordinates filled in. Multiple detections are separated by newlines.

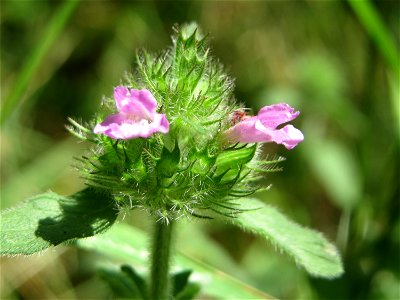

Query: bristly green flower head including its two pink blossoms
left=71, top=27, right=303, bottom=222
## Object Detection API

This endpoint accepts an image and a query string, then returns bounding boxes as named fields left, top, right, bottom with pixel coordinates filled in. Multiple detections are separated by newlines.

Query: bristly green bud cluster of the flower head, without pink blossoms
left=70, top=24, right=280, bottom=222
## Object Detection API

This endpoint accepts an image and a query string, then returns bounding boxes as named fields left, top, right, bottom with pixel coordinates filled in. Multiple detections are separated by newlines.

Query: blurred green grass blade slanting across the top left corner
left=0, top=0, right=79, bottom=124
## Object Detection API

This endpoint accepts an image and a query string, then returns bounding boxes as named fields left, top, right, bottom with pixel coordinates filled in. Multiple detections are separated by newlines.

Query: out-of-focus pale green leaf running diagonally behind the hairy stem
left=77, top=224, right=273, bottom=299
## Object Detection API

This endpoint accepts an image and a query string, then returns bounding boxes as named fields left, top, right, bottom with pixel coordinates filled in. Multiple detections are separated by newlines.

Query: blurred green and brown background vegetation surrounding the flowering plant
left=0, top=0, right=400, bottom=299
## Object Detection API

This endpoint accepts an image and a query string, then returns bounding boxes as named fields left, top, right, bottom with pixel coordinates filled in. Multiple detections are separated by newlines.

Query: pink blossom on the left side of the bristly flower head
left=93, top=86, right=169, bottom=140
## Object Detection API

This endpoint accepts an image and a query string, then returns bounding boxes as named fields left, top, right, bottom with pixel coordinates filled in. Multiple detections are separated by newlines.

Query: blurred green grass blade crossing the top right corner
left=348, top=0, right=399, bottom=74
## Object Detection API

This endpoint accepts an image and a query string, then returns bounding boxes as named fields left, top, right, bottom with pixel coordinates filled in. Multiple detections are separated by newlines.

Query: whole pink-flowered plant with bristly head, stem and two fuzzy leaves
left=1, top=24, right=342, bottom=299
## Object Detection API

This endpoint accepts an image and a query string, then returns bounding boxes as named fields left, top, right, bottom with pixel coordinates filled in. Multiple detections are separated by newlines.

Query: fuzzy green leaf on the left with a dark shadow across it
left=0, top=189, right=117, bottom=255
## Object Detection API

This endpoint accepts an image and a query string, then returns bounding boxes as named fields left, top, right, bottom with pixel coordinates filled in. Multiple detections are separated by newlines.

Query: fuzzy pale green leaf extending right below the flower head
left=228, top=198, right=343, bottom=278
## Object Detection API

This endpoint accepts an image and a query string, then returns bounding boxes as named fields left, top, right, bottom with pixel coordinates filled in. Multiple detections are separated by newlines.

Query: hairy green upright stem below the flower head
left=150, top=222, right=173, bottom=300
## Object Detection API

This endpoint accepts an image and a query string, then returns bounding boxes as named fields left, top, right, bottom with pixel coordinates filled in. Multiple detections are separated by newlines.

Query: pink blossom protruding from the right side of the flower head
left=224, top=103, right=304, bottom=150
